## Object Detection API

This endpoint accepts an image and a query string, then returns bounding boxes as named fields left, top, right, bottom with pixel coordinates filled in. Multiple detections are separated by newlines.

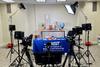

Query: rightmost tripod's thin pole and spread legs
left=83, top=30, right=95, bottom=67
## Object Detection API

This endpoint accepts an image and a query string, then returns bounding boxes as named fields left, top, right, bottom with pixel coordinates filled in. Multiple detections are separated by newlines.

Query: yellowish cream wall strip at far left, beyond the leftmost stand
left=0, top=4, right=10, bottom=45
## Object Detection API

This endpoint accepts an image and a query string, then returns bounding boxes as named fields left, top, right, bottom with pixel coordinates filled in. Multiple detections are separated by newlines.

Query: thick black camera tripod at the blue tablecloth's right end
left=62, top=37, right=80, bottom=67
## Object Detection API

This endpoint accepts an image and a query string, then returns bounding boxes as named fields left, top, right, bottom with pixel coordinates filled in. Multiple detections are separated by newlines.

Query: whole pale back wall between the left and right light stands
left=12, top=4, right=77, bottom=35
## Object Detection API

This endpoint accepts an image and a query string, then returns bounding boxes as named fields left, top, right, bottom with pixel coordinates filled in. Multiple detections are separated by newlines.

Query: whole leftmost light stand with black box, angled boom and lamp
left=7, top=3, right=26, bottom=62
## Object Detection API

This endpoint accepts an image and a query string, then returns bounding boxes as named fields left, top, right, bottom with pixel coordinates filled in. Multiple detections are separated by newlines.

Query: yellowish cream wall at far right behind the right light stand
left=77, top=2, right=100, bottom=42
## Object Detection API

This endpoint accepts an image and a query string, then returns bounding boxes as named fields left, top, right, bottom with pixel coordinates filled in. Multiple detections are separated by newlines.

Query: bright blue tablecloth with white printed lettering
left=33, top=38, right=70, bottom=53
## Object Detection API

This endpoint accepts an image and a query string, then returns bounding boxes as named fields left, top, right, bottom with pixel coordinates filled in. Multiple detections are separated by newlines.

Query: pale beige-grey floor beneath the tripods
left=0, top=45, right=100, bottom=67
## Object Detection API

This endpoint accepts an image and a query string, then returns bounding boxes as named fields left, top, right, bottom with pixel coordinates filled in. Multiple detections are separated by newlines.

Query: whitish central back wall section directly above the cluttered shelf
left=36, top=5, right=77, bottom=31
